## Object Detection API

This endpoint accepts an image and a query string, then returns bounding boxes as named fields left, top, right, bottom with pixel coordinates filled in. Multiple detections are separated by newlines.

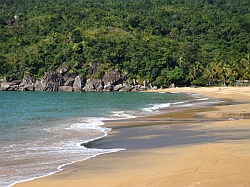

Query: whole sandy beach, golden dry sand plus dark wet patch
left=15, top=87, right=250, bottom=187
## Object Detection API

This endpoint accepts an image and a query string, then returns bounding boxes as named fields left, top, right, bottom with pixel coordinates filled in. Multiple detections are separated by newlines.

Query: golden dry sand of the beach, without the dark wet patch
left=16, top=87, right=250, bottom=187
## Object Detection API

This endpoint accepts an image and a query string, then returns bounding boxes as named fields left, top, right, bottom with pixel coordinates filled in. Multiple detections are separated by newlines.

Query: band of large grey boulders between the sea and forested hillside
left=0, top=66, right=147, bottom=92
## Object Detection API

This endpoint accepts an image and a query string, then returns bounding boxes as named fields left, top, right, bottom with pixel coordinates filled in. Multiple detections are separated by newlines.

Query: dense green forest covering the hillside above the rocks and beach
left=0, top=0, right=250, bottom=86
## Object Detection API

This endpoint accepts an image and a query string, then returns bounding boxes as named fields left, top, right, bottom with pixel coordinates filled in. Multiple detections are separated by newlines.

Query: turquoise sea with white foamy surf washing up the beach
left=0, top=92, right=217, bottom=187
